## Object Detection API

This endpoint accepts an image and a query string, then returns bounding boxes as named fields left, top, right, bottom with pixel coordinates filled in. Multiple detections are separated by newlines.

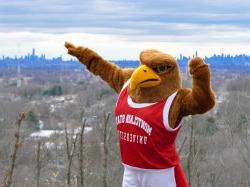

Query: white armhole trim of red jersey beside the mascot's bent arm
left=163, top=92, right=182, bottom=132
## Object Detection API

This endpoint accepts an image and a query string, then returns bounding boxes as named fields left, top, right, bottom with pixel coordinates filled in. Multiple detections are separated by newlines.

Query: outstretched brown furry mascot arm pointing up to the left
left=65, top=42, right=133, bottom=93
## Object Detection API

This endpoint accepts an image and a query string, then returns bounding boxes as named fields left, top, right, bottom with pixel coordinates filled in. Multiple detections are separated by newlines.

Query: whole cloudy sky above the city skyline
left=0, top=0, right=250, bottom=59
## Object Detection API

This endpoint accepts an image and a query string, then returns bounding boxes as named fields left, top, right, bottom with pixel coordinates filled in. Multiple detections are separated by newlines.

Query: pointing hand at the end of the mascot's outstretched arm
left=64, top=42, right=88, bottom=64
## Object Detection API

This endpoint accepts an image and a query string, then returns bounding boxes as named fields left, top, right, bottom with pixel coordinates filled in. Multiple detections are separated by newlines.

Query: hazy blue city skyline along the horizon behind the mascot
left=0, top=48, right=250, bottom=71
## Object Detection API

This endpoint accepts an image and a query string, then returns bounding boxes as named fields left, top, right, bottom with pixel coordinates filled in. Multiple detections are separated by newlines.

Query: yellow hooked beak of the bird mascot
left=130, top=65, right=161, bottom=90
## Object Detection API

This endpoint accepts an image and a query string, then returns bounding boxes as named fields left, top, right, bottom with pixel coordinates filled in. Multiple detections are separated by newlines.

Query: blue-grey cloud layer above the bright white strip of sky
left=0, top=0, right=250, bottom=40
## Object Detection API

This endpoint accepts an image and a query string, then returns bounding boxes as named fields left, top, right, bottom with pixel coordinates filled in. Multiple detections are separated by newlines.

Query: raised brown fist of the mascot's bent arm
left=188, top=57, right=208, bottom=75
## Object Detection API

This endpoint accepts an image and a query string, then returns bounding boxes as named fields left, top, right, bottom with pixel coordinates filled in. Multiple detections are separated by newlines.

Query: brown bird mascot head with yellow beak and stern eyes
left=129, top=50, right=181, bottom=103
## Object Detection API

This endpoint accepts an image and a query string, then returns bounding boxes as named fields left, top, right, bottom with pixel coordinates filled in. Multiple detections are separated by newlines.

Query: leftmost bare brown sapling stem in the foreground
left=3, top=113, right=25, bottom=187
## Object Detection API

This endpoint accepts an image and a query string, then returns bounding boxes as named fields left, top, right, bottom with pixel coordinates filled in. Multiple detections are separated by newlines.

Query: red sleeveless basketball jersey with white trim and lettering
left=115, top=82, right=181, bottom=169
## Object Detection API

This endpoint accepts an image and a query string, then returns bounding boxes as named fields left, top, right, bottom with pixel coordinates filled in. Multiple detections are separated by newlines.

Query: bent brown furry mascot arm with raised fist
left=179, top=57, right=215, bottom=116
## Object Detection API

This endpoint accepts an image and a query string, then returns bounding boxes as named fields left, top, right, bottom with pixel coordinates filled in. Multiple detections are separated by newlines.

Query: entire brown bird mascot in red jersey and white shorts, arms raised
left=65, top=42, right=215, bottom=187
